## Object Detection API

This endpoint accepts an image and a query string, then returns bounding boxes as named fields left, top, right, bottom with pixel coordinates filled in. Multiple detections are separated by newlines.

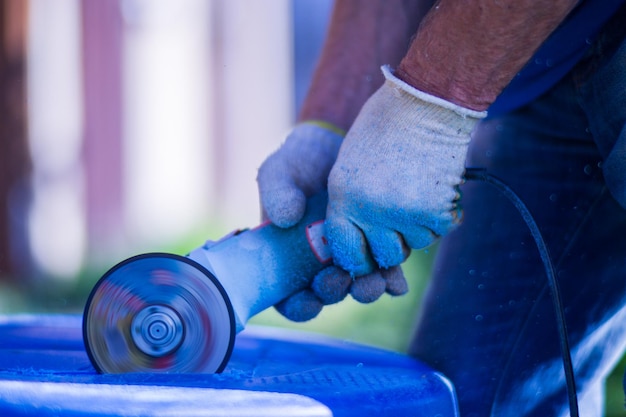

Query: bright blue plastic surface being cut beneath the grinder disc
left=0, top=315, right=458, bottom=417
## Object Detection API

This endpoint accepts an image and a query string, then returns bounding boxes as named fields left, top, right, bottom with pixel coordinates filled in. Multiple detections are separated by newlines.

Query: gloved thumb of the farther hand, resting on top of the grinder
left=257, top=154, right=306, bottom=227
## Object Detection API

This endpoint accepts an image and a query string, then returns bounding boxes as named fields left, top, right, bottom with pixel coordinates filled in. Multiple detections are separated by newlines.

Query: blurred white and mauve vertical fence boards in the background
left=28, top=0, right=331, bottom=277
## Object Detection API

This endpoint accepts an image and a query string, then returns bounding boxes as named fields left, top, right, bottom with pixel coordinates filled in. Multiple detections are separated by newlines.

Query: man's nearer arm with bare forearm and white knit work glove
left=325, top=0, right=574, bottom=276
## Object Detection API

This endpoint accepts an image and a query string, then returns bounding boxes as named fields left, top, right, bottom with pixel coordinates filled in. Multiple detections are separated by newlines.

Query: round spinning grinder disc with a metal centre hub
left=83, top=253, right=235, bottom=373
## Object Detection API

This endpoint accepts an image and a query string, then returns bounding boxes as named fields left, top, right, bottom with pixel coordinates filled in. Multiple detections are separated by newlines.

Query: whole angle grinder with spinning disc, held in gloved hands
left=83, top=193, right=332, bottom=373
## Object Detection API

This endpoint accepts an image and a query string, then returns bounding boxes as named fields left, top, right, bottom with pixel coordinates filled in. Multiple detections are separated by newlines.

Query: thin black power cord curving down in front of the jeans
left=465, top=168, right=579, bottom=417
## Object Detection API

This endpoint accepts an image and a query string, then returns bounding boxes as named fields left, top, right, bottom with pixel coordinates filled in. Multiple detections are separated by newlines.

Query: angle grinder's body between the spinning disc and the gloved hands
left=188, top=191, right=331, bottom=332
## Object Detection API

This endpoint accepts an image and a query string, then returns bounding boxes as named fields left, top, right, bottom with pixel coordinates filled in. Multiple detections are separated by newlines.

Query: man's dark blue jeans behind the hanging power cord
left=410, top=10, right=626, bottom=417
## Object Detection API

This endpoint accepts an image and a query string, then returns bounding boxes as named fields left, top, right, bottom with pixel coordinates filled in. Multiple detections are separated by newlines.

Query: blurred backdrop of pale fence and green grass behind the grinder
left=0, top=0, right=624, bottom=416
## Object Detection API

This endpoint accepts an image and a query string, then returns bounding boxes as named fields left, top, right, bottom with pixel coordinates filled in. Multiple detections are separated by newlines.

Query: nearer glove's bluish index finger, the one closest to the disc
left=324, top=211, right=376, bottom=276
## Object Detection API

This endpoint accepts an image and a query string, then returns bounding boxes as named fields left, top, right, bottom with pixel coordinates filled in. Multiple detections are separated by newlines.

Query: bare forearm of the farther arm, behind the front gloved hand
left=299, top=0, right=433, bottom=130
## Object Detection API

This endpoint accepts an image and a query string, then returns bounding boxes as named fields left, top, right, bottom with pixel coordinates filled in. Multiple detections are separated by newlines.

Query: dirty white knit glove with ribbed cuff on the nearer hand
left=326, top=67, right=486, bottom=276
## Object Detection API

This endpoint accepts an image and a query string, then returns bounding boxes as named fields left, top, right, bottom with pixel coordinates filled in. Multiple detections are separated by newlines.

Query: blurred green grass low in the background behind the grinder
left=0, top=242, right=626, bottom=417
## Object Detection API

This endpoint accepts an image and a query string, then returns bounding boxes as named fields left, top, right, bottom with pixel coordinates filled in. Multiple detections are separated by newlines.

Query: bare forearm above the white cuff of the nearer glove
left=396, top=0, right=577, bottom=110
